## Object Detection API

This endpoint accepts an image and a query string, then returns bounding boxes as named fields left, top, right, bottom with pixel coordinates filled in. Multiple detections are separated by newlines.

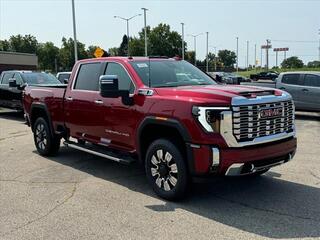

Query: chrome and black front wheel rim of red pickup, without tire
left=150, top=149, right=178, bottom=191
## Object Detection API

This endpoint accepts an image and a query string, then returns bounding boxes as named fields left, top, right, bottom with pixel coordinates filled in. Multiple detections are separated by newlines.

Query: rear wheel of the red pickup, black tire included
left=33, top=117, right=60, bottom=156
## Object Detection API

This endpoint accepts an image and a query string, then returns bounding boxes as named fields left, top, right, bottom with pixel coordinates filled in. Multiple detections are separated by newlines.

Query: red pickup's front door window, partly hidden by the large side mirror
left=105, top=63, right=134, bottom=93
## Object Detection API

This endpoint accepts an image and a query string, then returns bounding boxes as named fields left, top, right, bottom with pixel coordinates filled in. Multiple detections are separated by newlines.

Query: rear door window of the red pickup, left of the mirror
left=74, top=63, right=101, bottom=91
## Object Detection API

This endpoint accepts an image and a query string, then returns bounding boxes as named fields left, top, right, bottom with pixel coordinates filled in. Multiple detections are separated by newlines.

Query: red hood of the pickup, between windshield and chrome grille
left=155, top=85, right=282, bottom=105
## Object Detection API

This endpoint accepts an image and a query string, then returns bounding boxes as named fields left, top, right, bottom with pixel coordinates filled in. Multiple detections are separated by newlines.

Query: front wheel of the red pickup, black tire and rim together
left=145, top=139, right=189, bottom=201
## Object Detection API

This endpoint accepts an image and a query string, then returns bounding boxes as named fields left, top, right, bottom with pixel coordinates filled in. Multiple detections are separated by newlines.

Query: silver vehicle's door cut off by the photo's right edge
left=302, top=74, right=320, bottom=111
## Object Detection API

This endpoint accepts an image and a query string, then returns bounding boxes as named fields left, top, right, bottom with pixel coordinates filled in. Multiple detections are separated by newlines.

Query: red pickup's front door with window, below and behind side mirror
left=99, top=62, right=138, bottom=151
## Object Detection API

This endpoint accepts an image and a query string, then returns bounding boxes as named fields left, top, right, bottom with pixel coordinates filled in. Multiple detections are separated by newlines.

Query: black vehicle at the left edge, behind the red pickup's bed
left=0, top=70, right=61, bottom=110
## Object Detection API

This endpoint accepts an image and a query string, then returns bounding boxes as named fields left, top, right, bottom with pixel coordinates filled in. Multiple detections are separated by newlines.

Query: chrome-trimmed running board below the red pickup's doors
left=63, top=141, right=136, bottom=164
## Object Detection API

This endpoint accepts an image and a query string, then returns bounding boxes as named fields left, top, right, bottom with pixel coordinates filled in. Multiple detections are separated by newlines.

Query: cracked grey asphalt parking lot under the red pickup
left=0, top=109, right=320, bottom=239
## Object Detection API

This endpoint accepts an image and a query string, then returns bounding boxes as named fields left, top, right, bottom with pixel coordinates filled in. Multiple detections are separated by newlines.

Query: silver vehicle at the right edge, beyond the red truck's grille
left=276, top=71, right=320, bottom=112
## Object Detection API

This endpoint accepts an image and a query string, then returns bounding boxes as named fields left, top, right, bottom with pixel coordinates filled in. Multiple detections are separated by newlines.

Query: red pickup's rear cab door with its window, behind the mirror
left=64, top=62, right=104, bottom=143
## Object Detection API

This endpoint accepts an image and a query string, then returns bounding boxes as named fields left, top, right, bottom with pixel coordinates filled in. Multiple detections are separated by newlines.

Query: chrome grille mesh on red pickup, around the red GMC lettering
left=232, top=101, right=294, bottom=142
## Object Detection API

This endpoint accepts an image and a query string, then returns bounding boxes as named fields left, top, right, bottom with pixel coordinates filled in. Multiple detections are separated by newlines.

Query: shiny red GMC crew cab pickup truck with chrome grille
left=23, top=57, right=297, bottom=200
